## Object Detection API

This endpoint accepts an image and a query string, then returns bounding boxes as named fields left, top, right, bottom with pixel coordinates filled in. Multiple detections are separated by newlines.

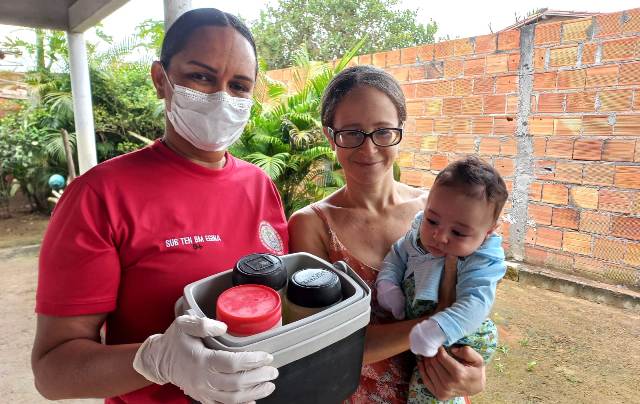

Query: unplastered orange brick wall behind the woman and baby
left=269, top=9, right=640, bottom=286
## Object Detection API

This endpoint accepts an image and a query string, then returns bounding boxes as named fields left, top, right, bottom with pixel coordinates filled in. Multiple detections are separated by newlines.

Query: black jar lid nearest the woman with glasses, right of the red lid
left=287, top=268, right=342, bottom=307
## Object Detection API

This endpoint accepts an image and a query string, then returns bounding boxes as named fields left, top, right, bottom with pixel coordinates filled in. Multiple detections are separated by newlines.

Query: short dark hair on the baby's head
left=433, top=156, right=509, bottom=220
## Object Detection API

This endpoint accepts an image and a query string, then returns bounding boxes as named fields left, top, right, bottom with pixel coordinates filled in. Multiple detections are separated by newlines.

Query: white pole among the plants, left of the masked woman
left=67, top=32, right=98, bottom=175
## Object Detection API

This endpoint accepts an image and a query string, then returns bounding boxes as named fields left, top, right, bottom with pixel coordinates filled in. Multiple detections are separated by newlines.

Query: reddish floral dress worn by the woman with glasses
left=311, top=205, right=415, bottom=404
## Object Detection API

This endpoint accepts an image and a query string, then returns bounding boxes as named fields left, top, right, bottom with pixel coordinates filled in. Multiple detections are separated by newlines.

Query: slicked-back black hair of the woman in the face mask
left=160, top=8, right=258, bottom=75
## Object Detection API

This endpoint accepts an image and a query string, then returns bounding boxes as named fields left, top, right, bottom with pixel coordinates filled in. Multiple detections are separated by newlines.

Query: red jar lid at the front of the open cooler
left=216, top=285, right=282, bottom=336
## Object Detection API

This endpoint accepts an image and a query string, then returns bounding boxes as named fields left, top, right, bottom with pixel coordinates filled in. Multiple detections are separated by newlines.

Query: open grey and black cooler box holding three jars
left=175, top=253, right=371, bottom=404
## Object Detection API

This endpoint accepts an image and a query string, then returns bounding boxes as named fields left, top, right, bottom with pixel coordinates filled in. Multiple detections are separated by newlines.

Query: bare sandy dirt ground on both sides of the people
left=0, top=219, right=640, bottom=404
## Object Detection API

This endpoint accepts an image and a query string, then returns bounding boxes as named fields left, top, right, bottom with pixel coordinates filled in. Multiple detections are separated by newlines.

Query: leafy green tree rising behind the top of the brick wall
left=251, top=0, right=437, bottom=69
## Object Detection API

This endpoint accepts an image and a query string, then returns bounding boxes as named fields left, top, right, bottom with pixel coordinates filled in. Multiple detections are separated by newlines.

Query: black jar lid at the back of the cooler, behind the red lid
left=231, top=254, right=287, bottom=290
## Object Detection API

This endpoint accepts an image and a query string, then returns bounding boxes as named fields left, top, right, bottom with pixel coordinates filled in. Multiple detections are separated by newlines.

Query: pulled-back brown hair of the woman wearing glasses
left=320, top=65, right=407, bottom=127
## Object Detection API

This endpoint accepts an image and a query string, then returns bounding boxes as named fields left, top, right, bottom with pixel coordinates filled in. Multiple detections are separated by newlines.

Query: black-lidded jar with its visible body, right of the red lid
left=285, top=268, right=342, bottom=324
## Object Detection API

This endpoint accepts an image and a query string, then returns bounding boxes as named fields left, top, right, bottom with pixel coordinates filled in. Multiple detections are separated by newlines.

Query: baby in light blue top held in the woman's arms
left=376, top=157, right=508, bottom=403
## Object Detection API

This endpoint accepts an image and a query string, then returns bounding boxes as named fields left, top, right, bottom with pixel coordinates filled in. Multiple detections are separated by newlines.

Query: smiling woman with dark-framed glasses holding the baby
left=289, top=66, right=484, bottom=403
